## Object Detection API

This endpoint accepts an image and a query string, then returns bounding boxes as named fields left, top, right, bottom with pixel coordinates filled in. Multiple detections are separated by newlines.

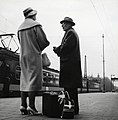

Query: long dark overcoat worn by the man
left=54, top=28, right=82, bottom=88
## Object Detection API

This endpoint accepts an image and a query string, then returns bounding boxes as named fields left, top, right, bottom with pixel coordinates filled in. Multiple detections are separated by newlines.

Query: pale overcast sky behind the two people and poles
left=0, top=0, right=118, bottom=78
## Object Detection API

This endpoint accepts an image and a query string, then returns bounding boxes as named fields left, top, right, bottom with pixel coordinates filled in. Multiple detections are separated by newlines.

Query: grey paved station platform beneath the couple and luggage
left=0, top=92, right=118, bottom=120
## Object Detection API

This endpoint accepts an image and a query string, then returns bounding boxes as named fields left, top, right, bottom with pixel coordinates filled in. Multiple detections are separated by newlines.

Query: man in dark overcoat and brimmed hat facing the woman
left=53, top=17, right=82, bottom=114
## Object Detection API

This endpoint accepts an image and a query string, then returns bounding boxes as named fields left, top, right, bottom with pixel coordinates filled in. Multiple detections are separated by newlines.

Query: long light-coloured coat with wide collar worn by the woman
left=18, top=18, right=49, bottom=91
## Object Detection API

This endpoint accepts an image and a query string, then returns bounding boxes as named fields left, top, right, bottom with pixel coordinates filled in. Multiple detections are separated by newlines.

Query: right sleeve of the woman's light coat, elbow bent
left=34, top=26, right=50, bottom=51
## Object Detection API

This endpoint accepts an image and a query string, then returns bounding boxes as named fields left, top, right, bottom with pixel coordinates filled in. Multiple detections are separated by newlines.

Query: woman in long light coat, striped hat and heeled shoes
left=18, top=7, right=49, bottom=115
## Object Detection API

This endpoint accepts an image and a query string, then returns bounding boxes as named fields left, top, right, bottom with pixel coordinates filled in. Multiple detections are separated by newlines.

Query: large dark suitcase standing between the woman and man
left=42, top=92, right=63, bottom=118
